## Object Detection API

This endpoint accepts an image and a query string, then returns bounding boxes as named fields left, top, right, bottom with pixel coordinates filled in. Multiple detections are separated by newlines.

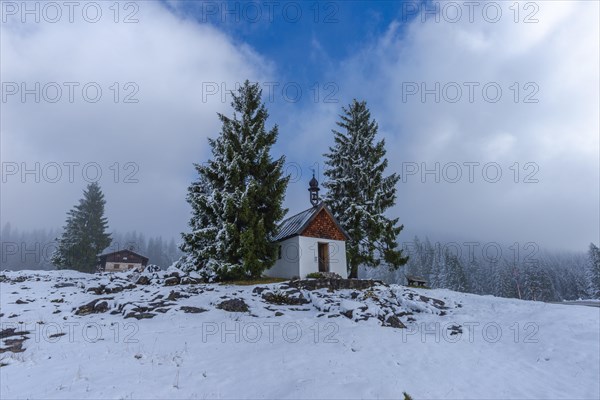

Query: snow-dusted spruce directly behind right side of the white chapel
left=324, top=100, right=408, bottom=278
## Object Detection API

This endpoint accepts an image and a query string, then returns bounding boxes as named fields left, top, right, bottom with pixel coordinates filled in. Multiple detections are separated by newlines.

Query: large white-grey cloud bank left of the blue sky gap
left=1, top=2, right=272, bottom=236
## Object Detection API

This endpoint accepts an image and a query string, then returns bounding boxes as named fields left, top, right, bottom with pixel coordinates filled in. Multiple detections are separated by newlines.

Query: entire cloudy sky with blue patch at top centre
left=0, top=0, right=600, bottom=250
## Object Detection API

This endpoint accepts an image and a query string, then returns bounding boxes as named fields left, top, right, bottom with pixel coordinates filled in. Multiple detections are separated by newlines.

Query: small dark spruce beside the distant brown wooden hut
left=52, top=182, right=111, bottom=273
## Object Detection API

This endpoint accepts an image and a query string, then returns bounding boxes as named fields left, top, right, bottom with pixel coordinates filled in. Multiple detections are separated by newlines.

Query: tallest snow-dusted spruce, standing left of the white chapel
left=180, top=81, right=289, bottom=280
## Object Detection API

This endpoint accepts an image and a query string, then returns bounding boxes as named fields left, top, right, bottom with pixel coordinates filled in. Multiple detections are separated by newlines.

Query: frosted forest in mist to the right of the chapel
left=361, top=237, right=600, bottom=301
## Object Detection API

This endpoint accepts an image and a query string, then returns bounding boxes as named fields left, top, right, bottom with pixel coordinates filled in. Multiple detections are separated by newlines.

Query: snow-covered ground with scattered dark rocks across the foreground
left=0, top=271, right=600, bottom=399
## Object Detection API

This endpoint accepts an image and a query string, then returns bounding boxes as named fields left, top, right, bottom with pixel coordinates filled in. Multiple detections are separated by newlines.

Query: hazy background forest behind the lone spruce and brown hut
left=0, top=223, right=181, bottom=270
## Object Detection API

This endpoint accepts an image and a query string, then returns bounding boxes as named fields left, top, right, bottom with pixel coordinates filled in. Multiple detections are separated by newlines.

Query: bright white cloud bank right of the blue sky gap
left=300, top=1, right=600, bottom=249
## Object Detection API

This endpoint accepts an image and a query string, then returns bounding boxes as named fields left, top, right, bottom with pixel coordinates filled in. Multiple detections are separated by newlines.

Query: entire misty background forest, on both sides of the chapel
left=0, top=222, right=600, bottom=301
